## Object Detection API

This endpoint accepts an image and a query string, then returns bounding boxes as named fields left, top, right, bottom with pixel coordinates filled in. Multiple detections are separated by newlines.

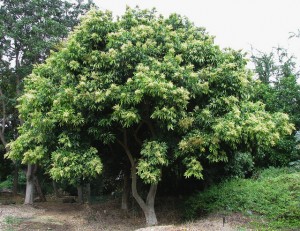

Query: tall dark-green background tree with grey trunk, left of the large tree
left=0, top=0, right=93, bottom=203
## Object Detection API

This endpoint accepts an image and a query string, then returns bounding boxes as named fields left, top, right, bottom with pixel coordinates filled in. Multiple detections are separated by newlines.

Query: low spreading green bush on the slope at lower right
left=185, top=168, right=300, bottom=228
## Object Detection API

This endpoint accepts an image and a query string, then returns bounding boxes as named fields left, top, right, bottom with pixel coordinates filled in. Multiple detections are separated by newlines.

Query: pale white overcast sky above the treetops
left=94, top=0, right=300, bottom=69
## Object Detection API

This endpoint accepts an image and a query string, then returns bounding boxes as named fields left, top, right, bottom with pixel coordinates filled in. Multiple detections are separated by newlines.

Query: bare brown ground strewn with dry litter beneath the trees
left=0, top=194, right=249, bottom=231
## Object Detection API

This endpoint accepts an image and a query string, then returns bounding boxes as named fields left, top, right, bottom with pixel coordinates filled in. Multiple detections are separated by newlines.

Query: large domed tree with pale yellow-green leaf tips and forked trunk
left=9, top=8, right=293, bottom=225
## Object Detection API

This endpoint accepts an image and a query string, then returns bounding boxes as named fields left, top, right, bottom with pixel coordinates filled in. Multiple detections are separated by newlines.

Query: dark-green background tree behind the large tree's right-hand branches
left=252, top=47, right=300, bottom=166
